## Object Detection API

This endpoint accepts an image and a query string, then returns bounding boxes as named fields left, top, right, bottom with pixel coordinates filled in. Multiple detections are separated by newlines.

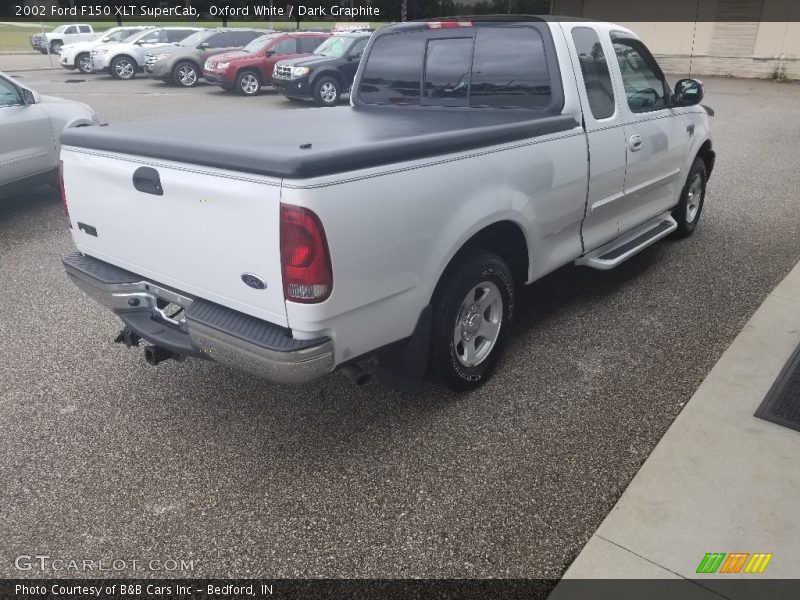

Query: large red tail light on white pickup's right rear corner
left=281, top=204, right=333, bottom=304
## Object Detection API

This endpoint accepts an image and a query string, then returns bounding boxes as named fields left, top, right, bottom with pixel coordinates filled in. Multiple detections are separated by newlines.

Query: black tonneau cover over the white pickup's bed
left=61, top=107, right=578, bottom=179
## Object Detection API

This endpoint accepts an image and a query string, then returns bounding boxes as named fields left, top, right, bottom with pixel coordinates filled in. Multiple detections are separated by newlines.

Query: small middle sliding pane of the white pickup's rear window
left=422, top=37, right=472, bottom=106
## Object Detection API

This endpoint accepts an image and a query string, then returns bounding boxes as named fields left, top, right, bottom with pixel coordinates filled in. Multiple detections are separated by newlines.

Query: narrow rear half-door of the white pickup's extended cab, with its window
left=564, top=24, right=626, bottom=252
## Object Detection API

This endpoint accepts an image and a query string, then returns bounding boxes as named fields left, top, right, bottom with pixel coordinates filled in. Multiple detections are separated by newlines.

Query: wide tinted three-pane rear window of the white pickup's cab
left=358, top=26, right=560, bottom=109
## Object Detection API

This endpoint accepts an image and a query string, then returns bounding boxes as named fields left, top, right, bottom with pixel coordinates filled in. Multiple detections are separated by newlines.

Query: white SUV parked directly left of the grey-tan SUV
left=91, top=27, right=200, bottom=79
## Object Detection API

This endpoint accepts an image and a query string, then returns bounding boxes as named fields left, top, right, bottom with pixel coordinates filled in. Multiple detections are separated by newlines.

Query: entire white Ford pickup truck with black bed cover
left=62, top=17, right=714, bottom=390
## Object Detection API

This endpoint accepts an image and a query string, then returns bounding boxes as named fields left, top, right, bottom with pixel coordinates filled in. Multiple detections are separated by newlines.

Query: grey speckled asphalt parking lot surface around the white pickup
left=0, top=56, right=800, bottom=578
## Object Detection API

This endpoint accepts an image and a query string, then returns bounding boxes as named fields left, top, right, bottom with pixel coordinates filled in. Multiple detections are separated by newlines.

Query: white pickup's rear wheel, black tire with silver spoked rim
left=431, top=253, right=514, bottom=392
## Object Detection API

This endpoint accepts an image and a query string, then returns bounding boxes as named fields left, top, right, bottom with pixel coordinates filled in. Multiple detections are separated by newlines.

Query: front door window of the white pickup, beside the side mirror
left=611, top=34, right=669, bottom=112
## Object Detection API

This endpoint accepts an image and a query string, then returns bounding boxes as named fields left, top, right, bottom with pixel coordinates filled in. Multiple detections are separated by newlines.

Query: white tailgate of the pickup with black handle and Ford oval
left=61, top=146, right=288, bottom=327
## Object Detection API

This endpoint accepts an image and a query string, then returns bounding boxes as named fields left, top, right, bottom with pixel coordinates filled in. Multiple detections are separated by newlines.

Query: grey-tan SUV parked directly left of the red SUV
left=144, top=28, right=264, bottom=87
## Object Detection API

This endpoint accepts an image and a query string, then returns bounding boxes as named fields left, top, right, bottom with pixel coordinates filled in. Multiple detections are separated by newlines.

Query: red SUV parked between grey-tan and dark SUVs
left=203, top=31, right=330, bottom=96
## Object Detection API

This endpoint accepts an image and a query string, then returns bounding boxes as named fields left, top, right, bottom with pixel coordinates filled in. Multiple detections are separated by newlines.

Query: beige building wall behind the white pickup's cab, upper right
left=552, top=0, right=800, bottom=79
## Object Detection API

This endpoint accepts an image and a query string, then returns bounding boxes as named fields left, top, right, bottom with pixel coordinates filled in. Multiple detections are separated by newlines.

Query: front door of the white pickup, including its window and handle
left=608, top=32, right=689, bottom=233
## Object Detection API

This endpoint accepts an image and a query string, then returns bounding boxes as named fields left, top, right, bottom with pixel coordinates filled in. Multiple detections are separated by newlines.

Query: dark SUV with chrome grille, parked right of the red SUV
left=272, top=32, right=372, bottom=106
